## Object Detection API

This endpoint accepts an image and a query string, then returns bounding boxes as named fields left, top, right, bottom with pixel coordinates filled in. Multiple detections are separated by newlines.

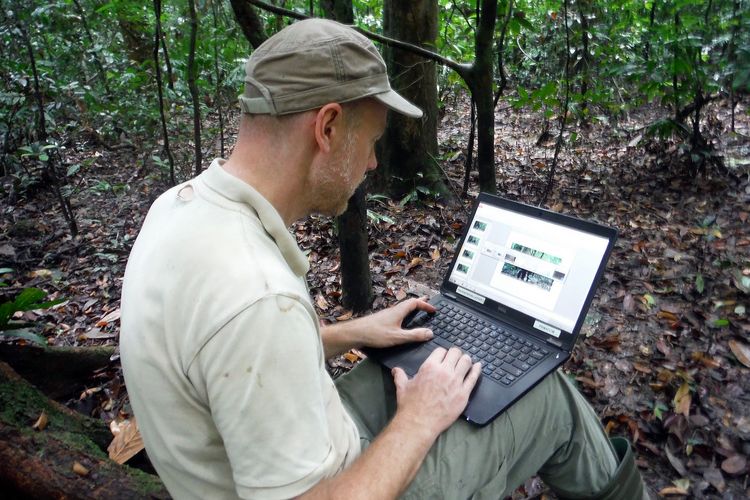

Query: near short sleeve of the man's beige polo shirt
left=188, top=295, right=341, bottom=498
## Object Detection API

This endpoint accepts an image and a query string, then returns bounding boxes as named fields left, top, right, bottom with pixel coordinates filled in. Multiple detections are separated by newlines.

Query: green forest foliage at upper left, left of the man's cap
left=0, top=0, right=249, bottom=184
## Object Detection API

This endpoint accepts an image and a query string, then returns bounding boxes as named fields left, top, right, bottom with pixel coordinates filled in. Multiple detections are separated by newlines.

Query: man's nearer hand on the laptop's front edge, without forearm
left=391, top=347, right=482, bottom=437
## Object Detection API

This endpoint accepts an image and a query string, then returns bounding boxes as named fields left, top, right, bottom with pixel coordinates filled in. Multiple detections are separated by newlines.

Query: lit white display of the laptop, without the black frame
left=448, top=202, right=609, bottom=337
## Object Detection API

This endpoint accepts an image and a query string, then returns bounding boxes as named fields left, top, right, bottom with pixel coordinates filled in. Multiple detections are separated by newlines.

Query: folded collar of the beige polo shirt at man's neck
left=200, top=158, right=310, bottom=276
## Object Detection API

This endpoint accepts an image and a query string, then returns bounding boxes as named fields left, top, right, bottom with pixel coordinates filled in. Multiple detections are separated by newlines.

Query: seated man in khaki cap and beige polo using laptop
left=121, top=20, right=643, bottom=499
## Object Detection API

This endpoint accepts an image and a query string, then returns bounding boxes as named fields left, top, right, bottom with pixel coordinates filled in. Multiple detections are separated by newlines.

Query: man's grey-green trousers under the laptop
left=336, top=360, right=617, bottom=500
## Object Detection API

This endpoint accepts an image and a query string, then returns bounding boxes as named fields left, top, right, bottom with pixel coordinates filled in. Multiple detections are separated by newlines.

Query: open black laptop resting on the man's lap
left=365, top=193, right=617, bottom=426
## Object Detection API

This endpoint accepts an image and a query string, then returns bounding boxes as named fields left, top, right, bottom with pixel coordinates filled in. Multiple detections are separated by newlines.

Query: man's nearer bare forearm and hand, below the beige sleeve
left=300, top=348, right=481, bottom=499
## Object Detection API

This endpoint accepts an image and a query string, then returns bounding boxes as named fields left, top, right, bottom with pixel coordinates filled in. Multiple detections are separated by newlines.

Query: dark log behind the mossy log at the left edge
left=0, top=343, right=115, bottom=400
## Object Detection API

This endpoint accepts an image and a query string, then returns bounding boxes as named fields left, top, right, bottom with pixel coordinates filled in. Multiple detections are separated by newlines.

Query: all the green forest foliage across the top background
left=0, top=0, right=750, bottom=191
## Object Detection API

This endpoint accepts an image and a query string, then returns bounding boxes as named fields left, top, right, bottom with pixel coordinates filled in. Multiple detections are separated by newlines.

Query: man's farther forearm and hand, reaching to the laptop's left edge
left=320, top=299, right=435, bottom=358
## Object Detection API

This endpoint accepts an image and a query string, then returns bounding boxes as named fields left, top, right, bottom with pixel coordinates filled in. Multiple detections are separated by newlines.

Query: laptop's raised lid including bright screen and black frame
left=441, top=193, right=617, bottom=351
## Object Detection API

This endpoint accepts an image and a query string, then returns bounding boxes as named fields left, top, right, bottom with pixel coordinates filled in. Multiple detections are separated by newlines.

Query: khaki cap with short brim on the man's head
left=239, top=19, right=422, bottom=118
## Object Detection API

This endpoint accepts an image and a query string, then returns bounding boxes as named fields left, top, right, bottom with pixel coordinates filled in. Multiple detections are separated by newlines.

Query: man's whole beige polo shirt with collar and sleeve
left=120, top=160, right=360, bottom=499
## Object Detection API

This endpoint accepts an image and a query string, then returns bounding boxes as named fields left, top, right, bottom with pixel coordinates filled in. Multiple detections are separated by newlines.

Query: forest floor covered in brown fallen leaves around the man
left=0, top=93, right=750, bottom=499
